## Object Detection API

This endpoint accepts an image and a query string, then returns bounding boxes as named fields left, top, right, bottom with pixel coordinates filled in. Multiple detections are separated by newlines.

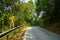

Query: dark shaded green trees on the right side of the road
left=36, top=0, right=60, bottom=33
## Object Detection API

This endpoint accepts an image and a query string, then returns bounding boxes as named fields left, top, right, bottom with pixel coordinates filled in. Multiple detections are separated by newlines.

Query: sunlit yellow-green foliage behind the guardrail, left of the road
left=0, top=0, right=35, bottom=32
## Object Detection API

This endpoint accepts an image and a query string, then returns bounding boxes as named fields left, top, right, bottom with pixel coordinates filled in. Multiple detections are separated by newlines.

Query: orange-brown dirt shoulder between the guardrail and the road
left=10, top=25, right=28, bottom=40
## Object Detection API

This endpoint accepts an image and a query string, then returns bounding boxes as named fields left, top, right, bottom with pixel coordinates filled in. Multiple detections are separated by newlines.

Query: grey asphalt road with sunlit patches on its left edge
left=22, top=26, right=60, bottom=40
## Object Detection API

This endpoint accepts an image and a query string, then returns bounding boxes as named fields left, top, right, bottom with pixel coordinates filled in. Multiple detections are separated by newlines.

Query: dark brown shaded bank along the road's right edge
left=44, top=23, right=60, bottom=34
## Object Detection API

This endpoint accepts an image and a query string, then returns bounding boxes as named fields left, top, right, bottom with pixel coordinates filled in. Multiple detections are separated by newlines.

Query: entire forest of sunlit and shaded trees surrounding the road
left=0, top=0, right=60, bottom=34
